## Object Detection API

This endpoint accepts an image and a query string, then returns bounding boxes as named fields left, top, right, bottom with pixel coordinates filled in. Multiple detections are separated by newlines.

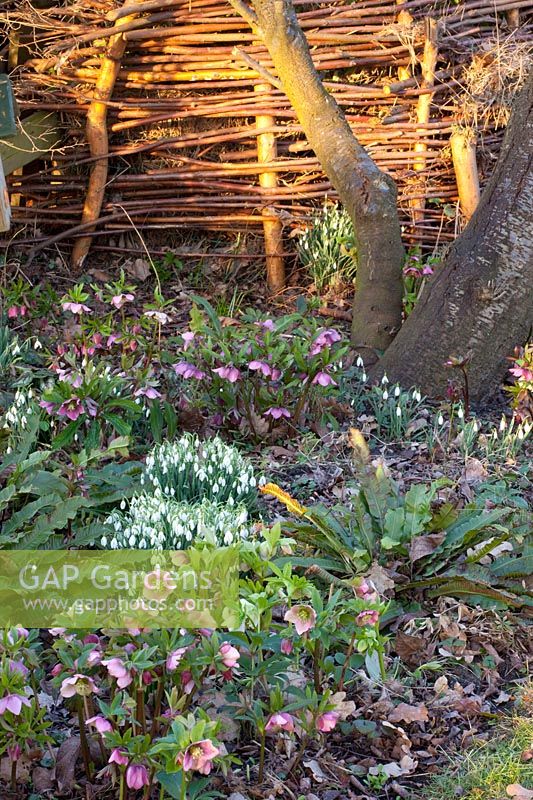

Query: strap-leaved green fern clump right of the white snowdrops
left=280, top=450, right=533, bottom=607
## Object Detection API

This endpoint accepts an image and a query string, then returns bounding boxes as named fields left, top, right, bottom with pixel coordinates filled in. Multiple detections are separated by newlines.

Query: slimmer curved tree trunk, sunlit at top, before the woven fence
left=230, top=0, right=404, bottom=362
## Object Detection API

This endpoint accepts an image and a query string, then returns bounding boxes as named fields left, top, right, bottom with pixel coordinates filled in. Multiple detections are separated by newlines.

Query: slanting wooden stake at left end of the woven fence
left=71, top=5, right=137, bottom=273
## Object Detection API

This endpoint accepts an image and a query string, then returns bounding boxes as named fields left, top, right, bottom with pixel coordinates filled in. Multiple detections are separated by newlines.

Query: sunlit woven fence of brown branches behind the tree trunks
left=2, top=0, right=533, bottom=267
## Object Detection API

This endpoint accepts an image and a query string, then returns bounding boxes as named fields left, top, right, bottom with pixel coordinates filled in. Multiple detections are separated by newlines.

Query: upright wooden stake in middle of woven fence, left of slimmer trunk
left=254, top=83, right=285, bottom=294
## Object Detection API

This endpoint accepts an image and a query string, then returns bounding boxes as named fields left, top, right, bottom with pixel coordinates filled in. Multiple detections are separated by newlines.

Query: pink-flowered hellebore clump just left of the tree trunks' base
left=169, top=297, right=347, bottom=441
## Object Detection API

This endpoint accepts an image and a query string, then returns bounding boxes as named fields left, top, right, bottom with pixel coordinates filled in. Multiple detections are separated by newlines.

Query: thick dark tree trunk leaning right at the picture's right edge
left=372, top=73, right=533, bottom=402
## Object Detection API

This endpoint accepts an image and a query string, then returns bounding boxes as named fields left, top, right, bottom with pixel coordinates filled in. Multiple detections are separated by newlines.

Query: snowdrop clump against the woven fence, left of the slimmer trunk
left=296, top=203, right=357, bottom=293
